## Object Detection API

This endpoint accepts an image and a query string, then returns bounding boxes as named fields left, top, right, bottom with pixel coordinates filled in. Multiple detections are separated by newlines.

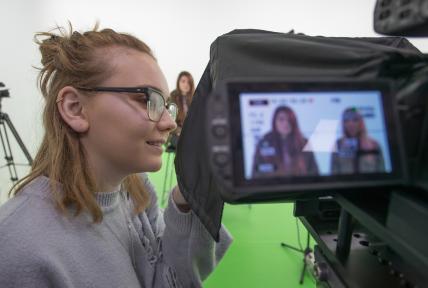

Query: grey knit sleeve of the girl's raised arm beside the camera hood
left=141, top=174, right=232, bottom=287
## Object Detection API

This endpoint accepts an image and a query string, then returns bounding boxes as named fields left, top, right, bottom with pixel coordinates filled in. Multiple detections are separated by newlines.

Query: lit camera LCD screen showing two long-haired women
left=231, top=83, right=399, bottom=186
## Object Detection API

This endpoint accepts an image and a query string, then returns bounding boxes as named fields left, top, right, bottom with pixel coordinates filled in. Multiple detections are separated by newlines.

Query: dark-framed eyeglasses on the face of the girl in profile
left=77, top=87, right=178, bottom=122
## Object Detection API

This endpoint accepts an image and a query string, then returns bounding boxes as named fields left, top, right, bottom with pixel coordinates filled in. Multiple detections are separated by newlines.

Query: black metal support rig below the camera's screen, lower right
left=298, top=188, right=428, bottom=288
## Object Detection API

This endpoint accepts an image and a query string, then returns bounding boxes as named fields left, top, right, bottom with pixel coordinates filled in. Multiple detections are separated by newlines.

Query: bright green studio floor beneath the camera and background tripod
left=149, top=153, right=315, bottom=288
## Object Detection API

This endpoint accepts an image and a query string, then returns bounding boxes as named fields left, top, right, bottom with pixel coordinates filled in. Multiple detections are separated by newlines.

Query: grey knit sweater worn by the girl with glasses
left=0, top=174, right=231, bottom=288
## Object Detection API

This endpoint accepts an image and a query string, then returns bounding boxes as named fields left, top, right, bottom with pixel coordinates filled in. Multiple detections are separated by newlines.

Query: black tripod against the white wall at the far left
left=0, top=82, right=33, bottom=183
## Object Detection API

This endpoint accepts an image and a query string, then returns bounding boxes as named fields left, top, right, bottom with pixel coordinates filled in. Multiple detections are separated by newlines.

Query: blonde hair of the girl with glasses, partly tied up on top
left=10, top=24, right=155, bottom=222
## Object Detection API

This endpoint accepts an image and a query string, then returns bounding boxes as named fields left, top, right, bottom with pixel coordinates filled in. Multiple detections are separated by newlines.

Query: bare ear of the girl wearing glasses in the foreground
left=56, top=86, right=89, bottom=133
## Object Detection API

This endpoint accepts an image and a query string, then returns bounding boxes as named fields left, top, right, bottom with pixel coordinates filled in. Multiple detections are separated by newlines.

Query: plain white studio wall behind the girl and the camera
left=0, top=0, right=428, bottom=199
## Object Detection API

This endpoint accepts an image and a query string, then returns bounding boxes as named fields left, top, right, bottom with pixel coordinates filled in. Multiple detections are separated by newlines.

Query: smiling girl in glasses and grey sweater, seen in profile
left=0, top=27, right=231, bottom=288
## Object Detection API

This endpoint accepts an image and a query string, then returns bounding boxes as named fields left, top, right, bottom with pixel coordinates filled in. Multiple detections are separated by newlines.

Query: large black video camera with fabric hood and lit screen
left=183, top=0, right=428, bottom=288
